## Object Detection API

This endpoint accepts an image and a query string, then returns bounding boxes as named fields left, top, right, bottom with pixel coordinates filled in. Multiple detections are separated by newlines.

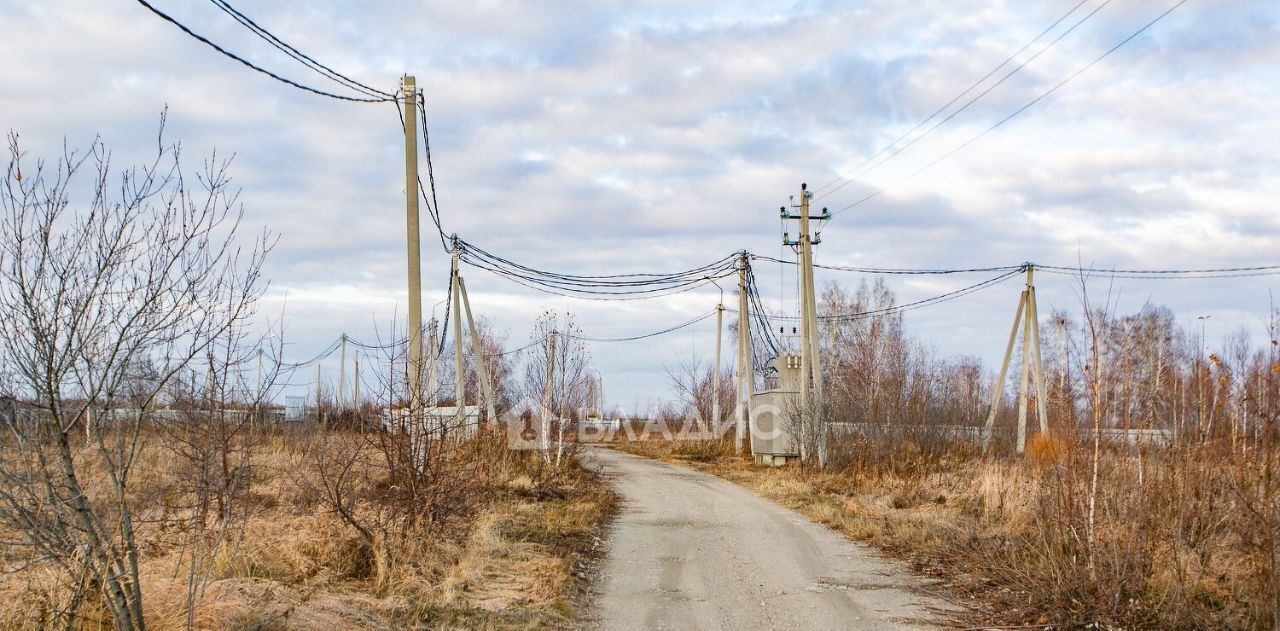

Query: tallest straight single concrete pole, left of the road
left=401, top=74, right=422, bottom=411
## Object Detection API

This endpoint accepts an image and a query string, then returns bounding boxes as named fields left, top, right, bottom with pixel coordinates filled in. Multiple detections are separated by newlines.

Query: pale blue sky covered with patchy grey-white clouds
left=0, top=0, right=1280, bottom=410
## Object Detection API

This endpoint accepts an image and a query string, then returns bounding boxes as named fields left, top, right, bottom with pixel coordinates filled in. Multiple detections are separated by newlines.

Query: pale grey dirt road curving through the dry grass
left=593, top=448, right=948, bottom=631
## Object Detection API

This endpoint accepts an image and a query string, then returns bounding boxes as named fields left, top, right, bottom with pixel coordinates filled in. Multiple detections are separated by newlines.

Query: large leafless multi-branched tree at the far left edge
left=0, top=122, right=270, bottom=630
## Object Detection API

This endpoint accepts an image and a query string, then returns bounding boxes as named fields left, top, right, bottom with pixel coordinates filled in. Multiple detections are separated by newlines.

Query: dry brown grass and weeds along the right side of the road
left=618, top=439, right=1277, bottom=630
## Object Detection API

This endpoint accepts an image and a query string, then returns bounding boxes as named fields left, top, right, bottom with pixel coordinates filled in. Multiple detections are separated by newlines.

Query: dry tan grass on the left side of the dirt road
left=0, top=436, right=616, bottom=630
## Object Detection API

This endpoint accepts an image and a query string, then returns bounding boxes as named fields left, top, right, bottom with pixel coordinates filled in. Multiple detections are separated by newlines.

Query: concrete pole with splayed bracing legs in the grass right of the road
left=982, top=264, right=1048, bottom=453
